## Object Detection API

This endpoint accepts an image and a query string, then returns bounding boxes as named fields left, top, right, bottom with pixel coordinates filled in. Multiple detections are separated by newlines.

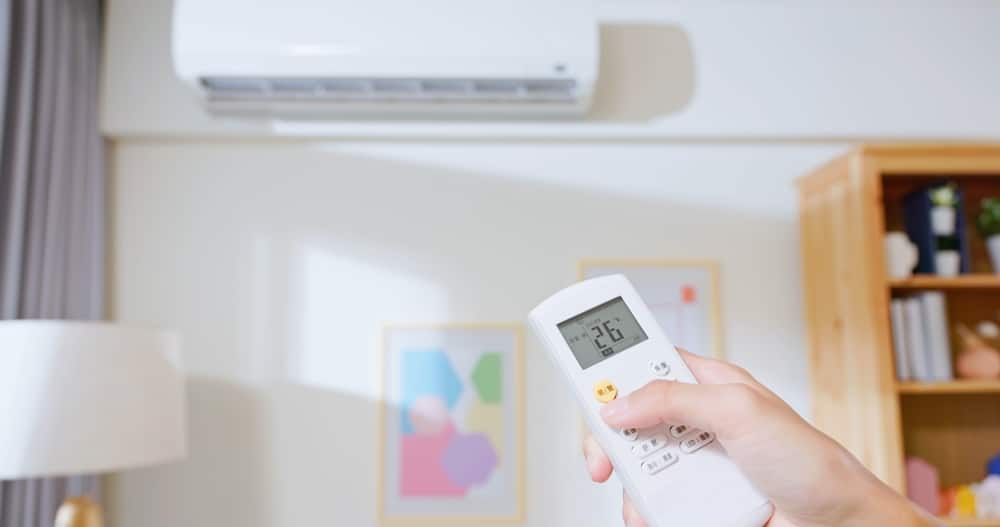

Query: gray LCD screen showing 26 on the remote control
left=559, top=297, right=648, bottom=369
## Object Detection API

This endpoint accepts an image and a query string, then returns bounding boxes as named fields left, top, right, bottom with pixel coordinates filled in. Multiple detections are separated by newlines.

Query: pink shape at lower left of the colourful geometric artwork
left=399, top=423, right=467, bottom=498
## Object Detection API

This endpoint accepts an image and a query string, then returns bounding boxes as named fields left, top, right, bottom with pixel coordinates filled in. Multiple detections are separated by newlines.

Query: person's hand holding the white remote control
left=583, top=350, right=938, bottom=527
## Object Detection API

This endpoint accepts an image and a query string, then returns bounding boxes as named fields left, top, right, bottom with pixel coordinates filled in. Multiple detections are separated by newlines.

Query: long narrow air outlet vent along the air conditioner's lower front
left=200, top=77, right=577, bottom=103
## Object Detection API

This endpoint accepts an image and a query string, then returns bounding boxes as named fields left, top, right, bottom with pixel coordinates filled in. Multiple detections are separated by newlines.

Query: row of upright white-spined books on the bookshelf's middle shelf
left=890, top=291, right=954, bottom=382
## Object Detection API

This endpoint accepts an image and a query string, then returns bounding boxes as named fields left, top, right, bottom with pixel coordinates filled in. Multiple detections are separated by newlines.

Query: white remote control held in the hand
left=529, top=275, right=773, bottom=527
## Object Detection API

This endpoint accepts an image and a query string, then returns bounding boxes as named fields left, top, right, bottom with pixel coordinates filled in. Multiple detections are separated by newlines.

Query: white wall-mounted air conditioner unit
left=173, top=0, right=599, bottom=121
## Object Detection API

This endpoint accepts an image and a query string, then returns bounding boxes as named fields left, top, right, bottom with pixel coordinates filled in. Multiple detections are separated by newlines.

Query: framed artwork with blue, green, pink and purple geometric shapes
left=378, top=324, right=524, bottom=525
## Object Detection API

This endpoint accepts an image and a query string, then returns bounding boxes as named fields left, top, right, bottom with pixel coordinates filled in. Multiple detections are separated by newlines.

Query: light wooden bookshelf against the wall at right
left=799, top=144, right=1000, bottom=512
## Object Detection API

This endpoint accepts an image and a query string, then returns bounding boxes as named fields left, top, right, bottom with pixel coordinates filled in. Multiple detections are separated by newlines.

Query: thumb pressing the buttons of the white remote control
left=601, top=381, right=764, bottom=440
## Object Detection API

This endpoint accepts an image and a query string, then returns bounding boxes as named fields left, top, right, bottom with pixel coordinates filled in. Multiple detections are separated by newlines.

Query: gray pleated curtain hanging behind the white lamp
left=0, top=0, right=106, bottom=527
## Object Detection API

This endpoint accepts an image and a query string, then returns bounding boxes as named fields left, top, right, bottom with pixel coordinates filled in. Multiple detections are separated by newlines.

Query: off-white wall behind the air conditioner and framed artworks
left=104, top=0, right=1000, bottom=527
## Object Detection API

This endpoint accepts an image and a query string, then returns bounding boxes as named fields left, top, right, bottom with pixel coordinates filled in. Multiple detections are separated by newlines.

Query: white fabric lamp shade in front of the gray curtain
left=0, top=320, right=187, bottom=479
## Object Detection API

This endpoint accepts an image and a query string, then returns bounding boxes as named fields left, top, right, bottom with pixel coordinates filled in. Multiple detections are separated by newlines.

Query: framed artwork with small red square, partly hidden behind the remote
left=579, top=260, right=723, bottom=358
